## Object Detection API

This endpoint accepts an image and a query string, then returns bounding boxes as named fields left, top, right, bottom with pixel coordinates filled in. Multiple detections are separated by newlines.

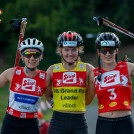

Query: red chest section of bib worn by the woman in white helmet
left=10, top=74, right=46, bottom=96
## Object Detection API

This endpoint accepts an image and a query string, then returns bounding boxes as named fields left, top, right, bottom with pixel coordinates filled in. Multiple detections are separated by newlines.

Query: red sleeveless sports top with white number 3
left=94, top=62, right=132, bottom=113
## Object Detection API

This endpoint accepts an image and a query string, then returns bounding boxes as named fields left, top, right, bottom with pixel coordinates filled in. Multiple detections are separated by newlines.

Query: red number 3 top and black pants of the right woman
left=94, top=62, right=134, bottom=134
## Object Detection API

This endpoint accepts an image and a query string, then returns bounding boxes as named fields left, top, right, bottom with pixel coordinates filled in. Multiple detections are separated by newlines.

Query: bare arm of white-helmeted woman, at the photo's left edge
left=0, top=68, right=15, bottom=88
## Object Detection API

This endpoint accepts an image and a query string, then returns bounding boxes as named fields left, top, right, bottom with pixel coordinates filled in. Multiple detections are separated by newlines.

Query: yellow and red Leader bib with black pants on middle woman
left=48, top=62, right=88, bottom=134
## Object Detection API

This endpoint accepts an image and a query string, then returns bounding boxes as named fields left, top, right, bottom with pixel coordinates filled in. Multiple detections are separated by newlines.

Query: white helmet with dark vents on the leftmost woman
left=19, top=38, right=44, bottom=53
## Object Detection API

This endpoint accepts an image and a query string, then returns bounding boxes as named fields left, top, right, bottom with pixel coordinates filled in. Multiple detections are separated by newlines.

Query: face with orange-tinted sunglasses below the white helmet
left=21, top=49, right=42, bottom=68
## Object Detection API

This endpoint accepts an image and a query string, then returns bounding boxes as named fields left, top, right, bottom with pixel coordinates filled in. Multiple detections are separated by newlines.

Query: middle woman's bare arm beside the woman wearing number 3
left=85, top=64, right=96, bottom=105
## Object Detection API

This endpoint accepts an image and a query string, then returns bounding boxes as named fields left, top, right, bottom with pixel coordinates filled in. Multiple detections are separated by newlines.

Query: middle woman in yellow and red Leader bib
left=47, top=31, right=94, bottom=134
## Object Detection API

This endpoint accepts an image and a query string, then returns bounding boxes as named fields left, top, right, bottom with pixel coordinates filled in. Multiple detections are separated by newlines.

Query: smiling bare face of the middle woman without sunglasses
left=61, top=47, right=79, bottom=63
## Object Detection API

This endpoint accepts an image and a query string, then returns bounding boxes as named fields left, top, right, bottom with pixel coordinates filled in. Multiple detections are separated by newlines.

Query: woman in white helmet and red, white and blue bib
left=0, top=38, right=50, bottom=134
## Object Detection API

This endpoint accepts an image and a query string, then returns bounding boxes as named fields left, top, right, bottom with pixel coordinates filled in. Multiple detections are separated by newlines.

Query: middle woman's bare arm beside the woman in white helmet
left=44, top=66, right=53, bottom=102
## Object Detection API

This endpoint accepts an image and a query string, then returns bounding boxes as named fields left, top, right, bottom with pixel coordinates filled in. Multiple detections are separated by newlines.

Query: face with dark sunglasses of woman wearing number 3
left=98, top=47, right=118, bottom=64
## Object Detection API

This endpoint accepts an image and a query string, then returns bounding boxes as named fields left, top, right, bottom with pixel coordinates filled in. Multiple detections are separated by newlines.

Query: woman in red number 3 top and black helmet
left=92, top=32, right=134, bottom=134
